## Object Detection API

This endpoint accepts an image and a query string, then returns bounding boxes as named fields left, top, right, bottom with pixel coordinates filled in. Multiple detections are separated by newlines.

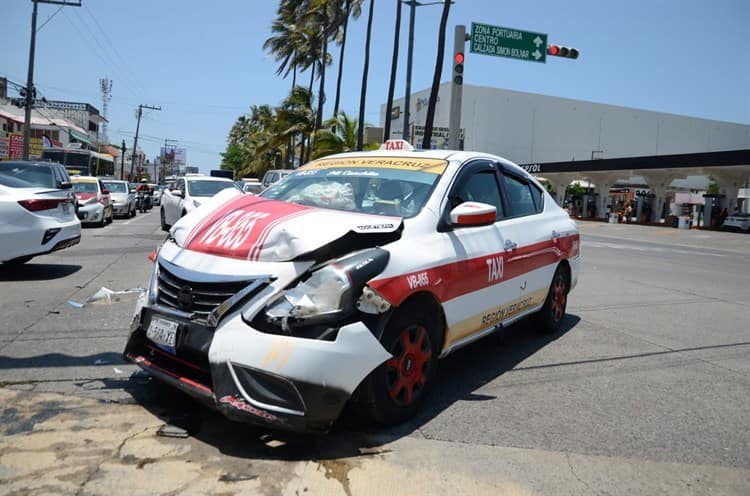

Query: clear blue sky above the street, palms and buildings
left=0, top=0, right=750, bottom=171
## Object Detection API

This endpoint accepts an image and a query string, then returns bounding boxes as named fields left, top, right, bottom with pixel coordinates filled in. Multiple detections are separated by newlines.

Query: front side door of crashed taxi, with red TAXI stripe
left=440, top=160, right=520, bottom=350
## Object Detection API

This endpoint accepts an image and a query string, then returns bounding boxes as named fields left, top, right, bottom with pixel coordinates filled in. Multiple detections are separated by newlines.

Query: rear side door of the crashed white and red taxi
left=500, top=166, right=561, bottom=316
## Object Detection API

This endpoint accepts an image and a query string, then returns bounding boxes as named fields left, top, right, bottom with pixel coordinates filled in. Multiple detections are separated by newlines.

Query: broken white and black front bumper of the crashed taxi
left=124, top=304, right=390, bottom=431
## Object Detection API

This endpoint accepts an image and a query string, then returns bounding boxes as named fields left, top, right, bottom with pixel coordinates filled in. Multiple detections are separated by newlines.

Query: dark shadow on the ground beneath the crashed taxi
left=114, top=315, right=580, bottom=461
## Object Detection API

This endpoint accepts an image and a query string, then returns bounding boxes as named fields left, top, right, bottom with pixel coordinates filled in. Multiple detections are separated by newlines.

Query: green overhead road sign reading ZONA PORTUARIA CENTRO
left=469, top=22, right=547, bottom=63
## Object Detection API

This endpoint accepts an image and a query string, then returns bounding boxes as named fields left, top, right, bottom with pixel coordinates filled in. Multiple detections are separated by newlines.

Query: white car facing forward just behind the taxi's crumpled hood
left=159, top=175, right=242, bottom=231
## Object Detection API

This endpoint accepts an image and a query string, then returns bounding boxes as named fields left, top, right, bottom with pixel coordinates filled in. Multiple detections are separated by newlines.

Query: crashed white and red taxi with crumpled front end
left=124, top=139, right=580, bottom=431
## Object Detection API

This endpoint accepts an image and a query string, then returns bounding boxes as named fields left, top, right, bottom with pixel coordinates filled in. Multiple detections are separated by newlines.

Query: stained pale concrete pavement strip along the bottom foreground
left=0, top=388, right=750, bottom=496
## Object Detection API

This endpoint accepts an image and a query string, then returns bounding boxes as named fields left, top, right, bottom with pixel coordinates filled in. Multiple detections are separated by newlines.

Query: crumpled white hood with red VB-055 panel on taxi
left=172, top=195, right=402, bottom=262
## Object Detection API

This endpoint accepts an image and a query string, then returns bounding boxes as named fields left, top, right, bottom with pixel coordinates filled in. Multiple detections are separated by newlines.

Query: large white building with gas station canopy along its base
left=380, top=83, right=750, bottom=219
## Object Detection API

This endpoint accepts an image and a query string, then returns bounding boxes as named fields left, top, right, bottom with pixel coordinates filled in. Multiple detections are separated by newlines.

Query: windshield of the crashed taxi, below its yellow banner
left=260, top=158, right=445, bottom=218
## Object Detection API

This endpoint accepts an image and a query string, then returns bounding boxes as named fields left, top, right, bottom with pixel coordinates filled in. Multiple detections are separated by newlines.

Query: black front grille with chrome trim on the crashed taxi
left=157, top=262, right=266, bottom=324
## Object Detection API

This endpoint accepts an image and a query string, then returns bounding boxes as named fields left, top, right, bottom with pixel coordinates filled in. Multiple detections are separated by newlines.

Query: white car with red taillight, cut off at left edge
left=0, top=175, right=81, bottom=265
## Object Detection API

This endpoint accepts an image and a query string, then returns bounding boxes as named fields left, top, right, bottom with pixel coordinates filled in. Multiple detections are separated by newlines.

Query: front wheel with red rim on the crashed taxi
left=360, top=305, right=442, bottom=425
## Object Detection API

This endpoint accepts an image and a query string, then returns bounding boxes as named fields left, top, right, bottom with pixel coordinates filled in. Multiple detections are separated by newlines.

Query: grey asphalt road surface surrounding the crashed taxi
left=0, top=214, right=750, bottom=494
